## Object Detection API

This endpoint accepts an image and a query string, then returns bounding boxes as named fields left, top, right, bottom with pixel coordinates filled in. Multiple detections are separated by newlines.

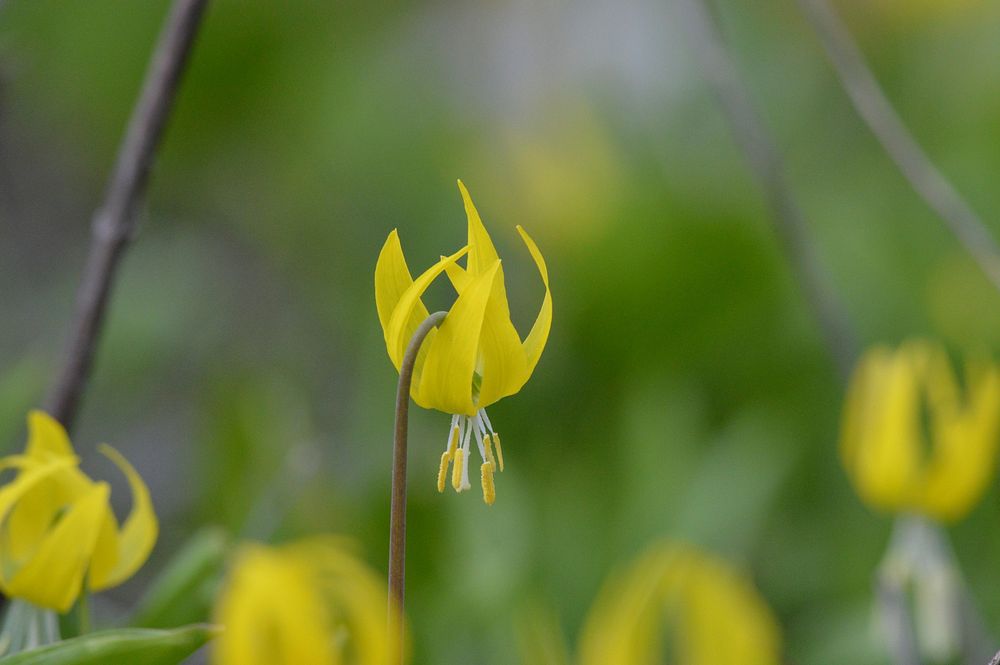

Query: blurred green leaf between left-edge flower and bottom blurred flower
left=129, top=527, right=230, bottom=628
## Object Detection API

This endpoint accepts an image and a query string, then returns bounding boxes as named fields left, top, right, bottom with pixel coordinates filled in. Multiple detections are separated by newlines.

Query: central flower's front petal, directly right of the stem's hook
left=416, top=260, right=500, bottom=416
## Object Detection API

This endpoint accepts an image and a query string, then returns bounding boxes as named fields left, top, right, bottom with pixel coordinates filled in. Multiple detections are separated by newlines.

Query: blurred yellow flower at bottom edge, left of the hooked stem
left=212, top=537, right=394, bottom=665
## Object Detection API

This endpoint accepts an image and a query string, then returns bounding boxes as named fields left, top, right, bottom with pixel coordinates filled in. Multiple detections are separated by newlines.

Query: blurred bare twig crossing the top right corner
left=799, top=0, right=1000, bottom=290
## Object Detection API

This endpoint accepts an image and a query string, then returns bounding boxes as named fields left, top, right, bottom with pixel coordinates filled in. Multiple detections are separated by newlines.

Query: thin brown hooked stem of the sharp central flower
left=389, top=312, right=448, bottom=663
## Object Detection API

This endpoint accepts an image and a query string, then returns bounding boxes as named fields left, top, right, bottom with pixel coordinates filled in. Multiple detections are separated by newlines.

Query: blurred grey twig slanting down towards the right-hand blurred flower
left=681, top=0, right=858, bottom=381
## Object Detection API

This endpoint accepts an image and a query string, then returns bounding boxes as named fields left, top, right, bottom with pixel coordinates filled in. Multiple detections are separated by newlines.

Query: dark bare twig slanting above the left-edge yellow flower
left=46, top=0, right=208, bottom=428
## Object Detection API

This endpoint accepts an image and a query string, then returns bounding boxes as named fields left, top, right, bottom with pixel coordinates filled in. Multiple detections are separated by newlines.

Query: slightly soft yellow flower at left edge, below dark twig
left=0, top=411, right=158, bottom=612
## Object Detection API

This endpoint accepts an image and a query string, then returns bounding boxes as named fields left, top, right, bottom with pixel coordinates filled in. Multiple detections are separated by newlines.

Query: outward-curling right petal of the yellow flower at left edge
left=90, top=445, right=159, bottom=591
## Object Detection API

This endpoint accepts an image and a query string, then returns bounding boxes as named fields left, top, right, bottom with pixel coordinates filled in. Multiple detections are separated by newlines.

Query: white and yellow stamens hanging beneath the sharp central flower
left=438, top=409, right=503, bottom=506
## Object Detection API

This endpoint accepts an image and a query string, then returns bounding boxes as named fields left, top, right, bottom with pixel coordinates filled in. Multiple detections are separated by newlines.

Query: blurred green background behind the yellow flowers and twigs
left=0, top=0, right=1000, bottom=665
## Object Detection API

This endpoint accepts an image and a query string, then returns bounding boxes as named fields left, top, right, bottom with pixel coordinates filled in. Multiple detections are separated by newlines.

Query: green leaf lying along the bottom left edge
left=0, top=624, right=219, bottom=665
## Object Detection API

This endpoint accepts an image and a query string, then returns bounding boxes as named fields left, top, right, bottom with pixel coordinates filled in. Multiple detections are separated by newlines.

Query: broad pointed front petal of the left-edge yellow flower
left=5, top=483, right=109, bottom=612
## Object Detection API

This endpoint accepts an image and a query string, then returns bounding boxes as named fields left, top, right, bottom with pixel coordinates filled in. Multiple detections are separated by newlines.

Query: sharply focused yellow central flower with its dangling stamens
left=375, top=180, right=552, bottom=504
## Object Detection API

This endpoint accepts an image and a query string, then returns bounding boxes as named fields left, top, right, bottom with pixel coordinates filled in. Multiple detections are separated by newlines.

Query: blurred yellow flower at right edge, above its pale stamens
left=840, top=341, right=1000, bottom=521
